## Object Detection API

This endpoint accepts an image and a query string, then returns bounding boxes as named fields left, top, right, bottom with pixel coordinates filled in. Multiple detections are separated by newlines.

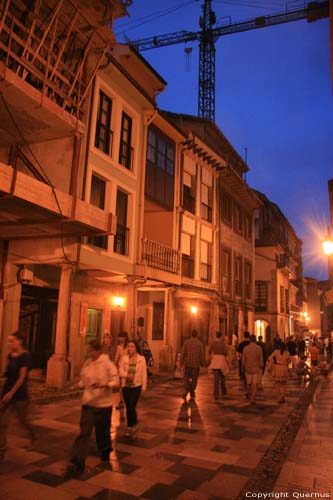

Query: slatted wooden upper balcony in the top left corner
left=0, top=0, right=115, bottom=143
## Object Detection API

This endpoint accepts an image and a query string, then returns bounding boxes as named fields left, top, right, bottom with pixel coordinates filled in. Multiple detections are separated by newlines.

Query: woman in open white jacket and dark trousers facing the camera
left=119, top=341, right=147, bottom=436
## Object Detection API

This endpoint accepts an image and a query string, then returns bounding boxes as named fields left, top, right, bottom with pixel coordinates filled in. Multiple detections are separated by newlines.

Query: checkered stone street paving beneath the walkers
left=0, top=372, right=326, bottom=500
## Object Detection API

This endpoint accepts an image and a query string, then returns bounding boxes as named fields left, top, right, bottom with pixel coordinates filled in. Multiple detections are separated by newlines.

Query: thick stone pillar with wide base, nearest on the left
left=46, top=266, right=73, bottom=389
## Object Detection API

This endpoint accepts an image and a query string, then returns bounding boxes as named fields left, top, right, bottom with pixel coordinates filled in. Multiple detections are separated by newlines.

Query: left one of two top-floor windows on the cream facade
left=95, top=91, right=113, bottom=156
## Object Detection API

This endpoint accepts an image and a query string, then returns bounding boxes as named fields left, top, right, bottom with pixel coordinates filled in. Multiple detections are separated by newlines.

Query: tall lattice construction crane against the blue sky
left=131, top=0, right=333, bottom=121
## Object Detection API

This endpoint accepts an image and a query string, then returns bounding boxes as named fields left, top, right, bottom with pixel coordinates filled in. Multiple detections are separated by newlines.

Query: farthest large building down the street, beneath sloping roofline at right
left=255, top=191, right=307, bottom=340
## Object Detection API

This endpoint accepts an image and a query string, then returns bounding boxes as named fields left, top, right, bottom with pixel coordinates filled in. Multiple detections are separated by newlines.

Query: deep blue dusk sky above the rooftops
left=115, top=0, right=333, bottom=279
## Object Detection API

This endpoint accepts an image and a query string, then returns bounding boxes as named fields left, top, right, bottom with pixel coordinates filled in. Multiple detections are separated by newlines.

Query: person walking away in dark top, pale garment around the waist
left=208, top=332, right=230, bottom=400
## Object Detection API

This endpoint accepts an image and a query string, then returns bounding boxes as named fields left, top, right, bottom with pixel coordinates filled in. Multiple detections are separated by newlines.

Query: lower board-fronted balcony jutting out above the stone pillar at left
left=0, top=163, right=116, bottom=240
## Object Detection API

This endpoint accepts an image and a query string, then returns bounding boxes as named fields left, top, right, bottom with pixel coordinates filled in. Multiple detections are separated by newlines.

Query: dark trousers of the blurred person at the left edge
left=0, top=400, right=35, bottom=455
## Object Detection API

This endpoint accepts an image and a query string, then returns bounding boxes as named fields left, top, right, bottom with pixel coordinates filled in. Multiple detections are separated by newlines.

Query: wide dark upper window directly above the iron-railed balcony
left=145, top=125, right=175, bottom=210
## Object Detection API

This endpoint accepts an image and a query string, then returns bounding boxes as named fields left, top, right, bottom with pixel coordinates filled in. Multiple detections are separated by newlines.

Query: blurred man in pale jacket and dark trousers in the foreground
left=66, top=340, right=119, bottom=475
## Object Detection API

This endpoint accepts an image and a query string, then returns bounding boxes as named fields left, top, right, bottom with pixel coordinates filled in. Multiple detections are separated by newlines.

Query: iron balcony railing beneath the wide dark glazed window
left=142, top=239, right=180, bottom=274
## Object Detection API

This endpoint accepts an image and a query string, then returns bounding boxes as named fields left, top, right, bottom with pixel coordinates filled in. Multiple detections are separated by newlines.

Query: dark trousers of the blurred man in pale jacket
left=70, top=405, right=112, bottom=467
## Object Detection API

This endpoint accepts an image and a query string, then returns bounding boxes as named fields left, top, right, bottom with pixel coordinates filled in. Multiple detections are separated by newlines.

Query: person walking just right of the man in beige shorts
left=267, top=341, right=291, bottom=403
